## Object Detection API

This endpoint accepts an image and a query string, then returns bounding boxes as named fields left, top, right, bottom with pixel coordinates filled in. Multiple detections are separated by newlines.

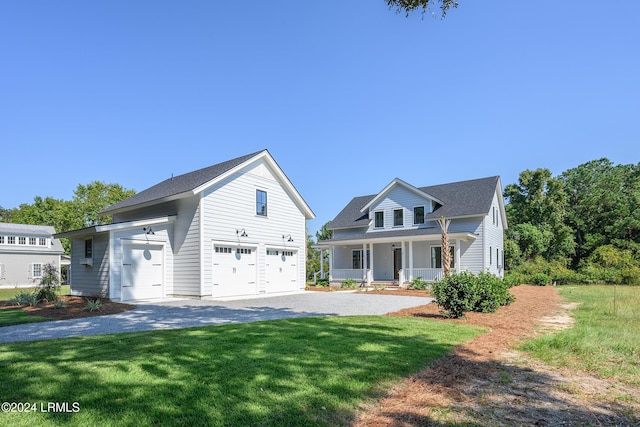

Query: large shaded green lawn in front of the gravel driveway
left=0, top=316, right=482, bottom=426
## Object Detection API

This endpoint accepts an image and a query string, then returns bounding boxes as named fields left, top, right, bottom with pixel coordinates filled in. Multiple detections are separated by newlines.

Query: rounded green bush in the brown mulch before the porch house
left=431, top=271, right=514, bottom=319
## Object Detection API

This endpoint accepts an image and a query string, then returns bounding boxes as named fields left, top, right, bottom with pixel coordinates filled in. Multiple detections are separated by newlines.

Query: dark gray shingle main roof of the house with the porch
left=328, top=176, right=504, bottom=229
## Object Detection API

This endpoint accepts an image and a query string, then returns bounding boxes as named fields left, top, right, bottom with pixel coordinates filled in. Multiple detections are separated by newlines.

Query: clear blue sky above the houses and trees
left=0, top=0, right=640, bottom=234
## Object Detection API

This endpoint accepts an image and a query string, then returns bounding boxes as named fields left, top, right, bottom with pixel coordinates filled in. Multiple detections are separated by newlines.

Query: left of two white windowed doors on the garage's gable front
left=213, top=245, right=258, bottom=297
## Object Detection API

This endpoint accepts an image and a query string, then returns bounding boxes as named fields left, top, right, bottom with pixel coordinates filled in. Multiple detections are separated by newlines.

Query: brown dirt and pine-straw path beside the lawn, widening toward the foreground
left=354, top=286, right=640, bottom=427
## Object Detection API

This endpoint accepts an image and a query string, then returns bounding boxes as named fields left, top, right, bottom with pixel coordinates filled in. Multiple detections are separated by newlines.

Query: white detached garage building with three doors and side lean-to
left=57, top=150, right=314, bottom=301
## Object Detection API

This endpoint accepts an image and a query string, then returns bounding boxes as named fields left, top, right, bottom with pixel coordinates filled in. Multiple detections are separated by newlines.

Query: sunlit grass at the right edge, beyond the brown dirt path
left=523, top=286, right=640, bottom=385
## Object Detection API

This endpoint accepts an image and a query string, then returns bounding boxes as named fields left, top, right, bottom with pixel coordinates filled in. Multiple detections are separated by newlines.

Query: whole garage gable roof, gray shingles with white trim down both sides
left=100, top=149, right=315, bottom=219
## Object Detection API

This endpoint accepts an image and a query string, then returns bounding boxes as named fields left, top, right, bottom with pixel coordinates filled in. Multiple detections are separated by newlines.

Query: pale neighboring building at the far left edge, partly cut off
left=0, top=222, right=64, bottom=287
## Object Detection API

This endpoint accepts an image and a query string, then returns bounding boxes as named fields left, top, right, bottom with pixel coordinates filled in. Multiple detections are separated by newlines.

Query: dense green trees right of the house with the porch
left=504, top=158, right=640, bottom=284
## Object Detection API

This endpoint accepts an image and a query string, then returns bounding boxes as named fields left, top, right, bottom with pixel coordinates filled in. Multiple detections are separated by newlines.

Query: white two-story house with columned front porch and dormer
left=316, top=176, right=507, bottom=284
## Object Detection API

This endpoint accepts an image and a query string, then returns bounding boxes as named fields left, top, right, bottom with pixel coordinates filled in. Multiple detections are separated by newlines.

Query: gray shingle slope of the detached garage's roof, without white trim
left=100, top=150, right=266, bottom=215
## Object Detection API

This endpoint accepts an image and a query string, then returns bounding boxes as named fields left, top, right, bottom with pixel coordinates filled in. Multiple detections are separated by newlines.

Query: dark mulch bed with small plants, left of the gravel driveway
left=0, top=295, right=136, bottom=320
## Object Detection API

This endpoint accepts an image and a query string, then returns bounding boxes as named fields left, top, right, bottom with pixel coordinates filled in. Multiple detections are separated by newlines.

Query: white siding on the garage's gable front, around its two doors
left=201, top=160, right=306, bottom=296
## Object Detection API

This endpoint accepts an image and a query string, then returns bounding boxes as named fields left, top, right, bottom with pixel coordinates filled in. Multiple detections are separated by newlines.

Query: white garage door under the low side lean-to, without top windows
left=122, top=244, right=163, bottom=301
